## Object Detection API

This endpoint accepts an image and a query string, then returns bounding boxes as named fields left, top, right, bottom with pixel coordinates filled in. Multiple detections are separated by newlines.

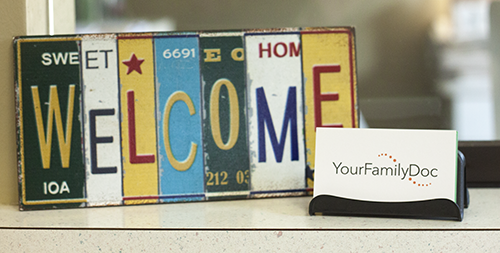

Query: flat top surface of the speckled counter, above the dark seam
left=0, top=188, right=500, bottom=230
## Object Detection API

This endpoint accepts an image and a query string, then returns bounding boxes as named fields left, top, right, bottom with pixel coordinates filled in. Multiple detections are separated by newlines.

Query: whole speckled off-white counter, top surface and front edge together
left=0, top=188, right=500, bottom=252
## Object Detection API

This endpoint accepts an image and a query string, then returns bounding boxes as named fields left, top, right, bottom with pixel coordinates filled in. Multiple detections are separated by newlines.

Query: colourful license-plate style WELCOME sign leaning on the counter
left=14, top=28, right=358, bottom=210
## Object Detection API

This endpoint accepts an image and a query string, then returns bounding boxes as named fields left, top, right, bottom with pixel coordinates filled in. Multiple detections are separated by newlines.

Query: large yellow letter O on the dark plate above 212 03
left=210, top=78, right=240, bottom=150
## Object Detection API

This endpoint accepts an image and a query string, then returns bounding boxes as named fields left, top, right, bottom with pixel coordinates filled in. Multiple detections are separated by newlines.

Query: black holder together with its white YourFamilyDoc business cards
left=310, top=128, right=466, bottom=220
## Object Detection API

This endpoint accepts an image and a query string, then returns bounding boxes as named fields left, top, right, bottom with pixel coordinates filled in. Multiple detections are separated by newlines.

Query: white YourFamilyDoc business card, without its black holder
left=314, top=128, right=458, bottom=203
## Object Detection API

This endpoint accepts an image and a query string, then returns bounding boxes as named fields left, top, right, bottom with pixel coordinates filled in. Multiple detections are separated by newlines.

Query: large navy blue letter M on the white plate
left=256, top=87, right=299, bottom=163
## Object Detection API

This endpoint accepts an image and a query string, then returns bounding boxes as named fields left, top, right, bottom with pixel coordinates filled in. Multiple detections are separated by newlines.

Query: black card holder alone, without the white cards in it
left=309, top=151, right=469, bottom=221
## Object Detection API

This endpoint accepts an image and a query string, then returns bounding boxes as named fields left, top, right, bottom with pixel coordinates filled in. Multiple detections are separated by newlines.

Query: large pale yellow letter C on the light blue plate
left=163, top=91, right=198, bottom=171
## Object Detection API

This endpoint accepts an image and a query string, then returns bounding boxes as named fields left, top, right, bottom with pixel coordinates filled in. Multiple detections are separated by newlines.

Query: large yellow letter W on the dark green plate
left=31, top=84, right=75, bottom=169
